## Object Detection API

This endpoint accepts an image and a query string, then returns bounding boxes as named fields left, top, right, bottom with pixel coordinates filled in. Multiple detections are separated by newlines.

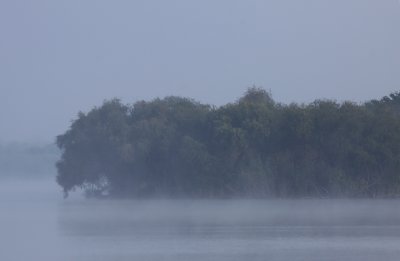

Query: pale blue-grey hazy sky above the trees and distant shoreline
left=0, top=0, right=400, bottom=142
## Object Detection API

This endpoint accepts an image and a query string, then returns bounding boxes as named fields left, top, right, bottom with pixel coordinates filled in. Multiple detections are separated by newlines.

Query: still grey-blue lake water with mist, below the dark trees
left=0, top=180, right=400, bottom=261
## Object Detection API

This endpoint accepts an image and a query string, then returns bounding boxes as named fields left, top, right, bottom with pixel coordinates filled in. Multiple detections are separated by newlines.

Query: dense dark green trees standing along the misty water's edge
left=57, top=88, right=400, bottom=197
